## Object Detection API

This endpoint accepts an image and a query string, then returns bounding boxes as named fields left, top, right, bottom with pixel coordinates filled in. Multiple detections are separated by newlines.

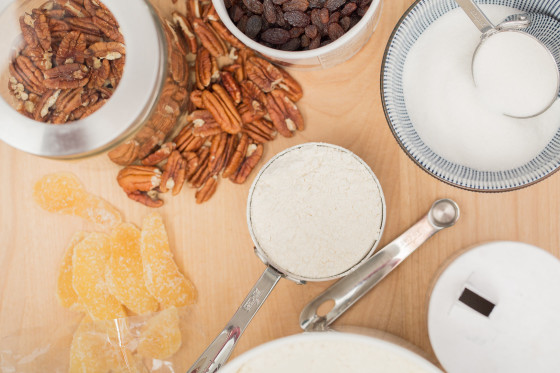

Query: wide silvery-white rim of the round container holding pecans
left=0, top=0, right=167, bottom=158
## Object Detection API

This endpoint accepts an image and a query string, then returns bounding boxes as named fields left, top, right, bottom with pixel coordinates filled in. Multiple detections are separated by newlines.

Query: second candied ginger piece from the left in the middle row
left=72, top=233, right=126, bottom=320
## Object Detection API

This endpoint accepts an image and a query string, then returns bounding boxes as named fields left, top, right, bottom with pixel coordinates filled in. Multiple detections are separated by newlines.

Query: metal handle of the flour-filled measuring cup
left=188, top=267, right=282, bottom=373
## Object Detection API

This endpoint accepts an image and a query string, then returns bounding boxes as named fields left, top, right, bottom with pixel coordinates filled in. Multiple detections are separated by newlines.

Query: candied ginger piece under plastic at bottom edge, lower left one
left=68, top=316, right=142, bottom=373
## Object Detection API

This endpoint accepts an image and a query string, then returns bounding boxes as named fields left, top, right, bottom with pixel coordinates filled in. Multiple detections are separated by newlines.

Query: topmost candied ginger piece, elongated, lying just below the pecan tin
left=33, top=172, right=122, bottom=228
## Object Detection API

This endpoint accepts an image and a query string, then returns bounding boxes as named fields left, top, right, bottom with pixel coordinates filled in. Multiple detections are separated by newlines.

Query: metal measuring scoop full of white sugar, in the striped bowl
left=456, top=0, right=560, bottom=118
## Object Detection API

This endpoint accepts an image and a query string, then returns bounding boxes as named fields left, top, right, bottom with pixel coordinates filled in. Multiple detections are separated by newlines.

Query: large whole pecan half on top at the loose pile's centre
left=202, top=84, right=242, bottom=134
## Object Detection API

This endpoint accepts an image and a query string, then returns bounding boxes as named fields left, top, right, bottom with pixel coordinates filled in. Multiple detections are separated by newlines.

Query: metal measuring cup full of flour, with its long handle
left=189, top=143, right=386, bottom=373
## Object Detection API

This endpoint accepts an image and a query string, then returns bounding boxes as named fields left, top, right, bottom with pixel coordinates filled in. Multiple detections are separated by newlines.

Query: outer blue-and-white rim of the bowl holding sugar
left=379, top=0, right=560, bottom=194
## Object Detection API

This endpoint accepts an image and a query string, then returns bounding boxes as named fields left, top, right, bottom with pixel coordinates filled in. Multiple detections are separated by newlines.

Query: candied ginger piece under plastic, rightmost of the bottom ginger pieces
left=138, top=307, right=182, bottom=360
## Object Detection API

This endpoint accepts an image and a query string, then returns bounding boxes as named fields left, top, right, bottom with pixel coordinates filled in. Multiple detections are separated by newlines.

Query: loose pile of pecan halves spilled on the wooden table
left=109, top=0, right=303, bottom=207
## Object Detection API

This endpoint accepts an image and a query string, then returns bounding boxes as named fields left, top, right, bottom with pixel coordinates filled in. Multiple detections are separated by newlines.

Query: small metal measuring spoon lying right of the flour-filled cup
left=299, top=199, right=459, bottom=331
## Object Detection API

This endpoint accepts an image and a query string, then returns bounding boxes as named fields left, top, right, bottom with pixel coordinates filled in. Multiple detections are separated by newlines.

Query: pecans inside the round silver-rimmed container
left=8, top=0, right=125, bottom=124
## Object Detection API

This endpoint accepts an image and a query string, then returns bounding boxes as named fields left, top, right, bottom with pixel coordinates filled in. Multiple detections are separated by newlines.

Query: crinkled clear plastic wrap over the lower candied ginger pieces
left=0, top=307, right=206, bottom=373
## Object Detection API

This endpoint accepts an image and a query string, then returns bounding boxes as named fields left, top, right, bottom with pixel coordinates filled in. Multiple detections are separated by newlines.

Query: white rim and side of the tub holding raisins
left=213, top=0, right=383, bottom=70
